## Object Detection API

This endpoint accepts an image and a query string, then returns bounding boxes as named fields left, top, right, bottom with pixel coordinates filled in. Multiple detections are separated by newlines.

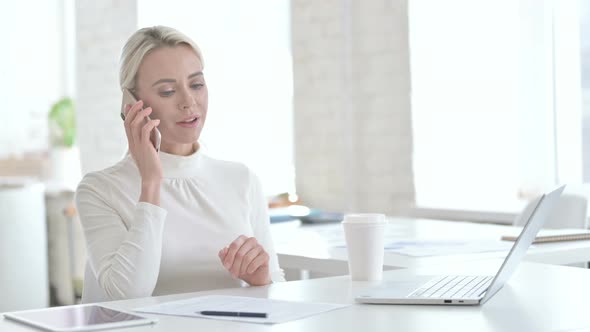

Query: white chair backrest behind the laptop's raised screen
left=513, top=194, right=588, bottom=229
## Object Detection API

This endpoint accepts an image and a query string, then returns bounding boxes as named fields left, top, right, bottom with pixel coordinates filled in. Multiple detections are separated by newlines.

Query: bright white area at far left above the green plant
left=0, top=0, right=66, bottom=158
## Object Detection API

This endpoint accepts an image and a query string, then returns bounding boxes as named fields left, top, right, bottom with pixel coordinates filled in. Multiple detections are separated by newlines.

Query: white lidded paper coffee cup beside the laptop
left=342, top=213, right=387, bottom=281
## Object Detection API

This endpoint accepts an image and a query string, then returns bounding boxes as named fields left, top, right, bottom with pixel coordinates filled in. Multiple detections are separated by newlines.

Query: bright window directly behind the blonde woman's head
left=138, top=0, right=295, bottom=194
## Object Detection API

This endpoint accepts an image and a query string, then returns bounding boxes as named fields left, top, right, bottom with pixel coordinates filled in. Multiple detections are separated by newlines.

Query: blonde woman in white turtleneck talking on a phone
left=76, top=26, right=284, bottom=303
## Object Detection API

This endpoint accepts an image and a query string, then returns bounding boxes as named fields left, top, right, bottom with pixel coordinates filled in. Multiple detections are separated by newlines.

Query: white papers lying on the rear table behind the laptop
left=385, top=240, right=513, bottom=257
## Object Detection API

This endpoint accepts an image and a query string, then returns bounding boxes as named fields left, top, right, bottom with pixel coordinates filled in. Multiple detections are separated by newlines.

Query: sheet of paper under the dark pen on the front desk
left=135, top=295, right=348, bottom=324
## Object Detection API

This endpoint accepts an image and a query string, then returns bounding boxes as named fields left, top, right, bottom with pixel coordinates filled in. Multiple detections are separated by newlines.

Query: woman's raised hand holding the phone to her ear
left=125, top=100, right=163, bottom=205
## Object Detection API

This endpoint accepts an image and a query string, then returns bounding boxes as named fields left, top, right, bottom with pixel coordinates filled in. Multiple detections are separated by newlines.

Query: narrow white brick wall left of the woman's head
left=76, top=0, right=137, bottom=173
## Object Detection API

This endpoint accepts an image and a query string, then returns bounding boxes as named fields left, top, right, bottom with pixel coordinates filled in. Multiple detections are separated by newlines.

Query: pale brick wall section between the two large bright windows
left=292, top=0, right=414, bottom=213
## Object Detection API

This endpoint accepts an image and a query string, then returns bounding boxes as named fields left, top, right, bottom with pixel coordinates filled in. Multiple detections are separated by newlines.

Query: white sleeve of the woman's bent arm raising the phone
left=76, top=176, right=167, bottom=300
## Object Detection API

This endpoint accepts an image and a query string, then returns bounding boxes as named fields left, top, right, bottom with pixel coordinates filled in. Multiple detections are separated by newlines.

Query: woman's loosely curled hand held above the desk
left=219, top=235, right=271, bottom=286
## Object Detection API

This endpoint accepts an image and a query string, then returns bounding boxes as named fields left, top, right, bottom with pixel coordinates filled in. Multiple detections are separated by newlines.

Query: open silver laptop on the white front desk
left=356, top=186, right=565, bottom=305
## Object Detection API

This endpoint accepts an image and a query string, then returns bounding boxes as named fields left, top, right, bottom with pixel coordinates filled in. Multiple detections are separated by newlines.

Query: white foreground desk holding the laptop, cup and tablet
left=0, top=260, right=590, bottom=332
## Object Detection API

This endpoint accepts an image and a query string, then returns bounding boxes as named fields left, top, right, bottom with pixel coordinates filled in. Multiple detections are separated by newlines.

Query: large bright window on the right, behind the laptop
left=409, top=0, right=590, bottom=212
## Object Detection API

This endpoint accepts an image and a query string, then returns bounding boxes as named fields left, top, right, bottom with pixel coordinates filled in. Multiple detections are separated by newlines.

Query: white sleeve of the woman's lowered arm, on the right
left=249, top=172, right=285, bottom=282
